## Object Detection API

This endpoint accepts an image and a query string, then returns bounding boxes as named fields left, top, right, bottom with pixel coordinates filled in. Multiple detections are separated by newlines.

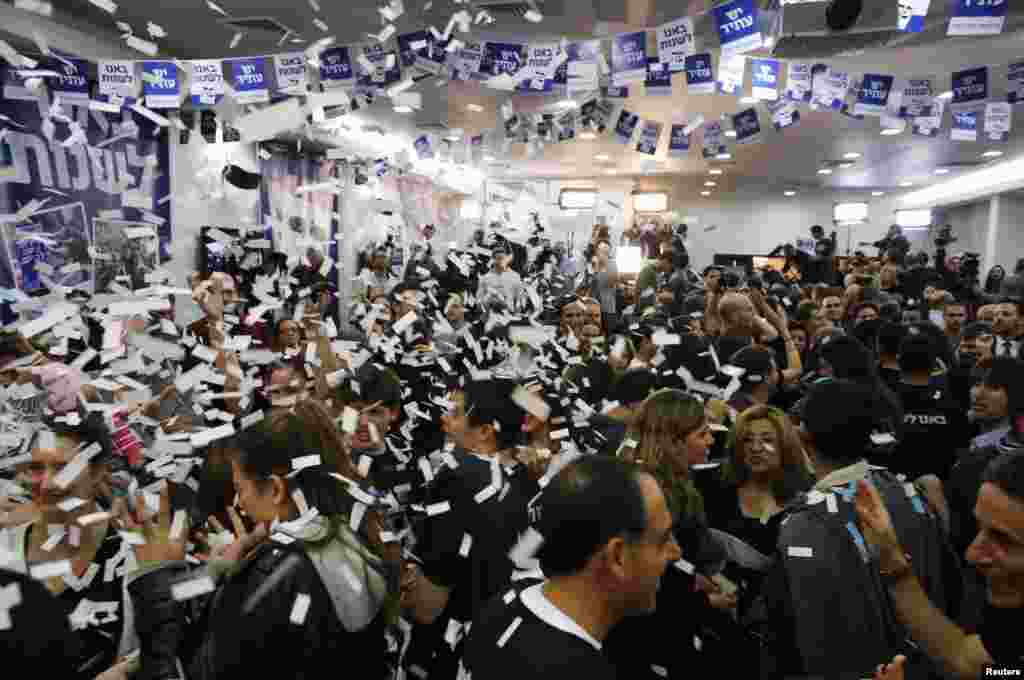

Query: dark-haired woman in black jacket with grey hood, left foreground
left=119, top=412, right=397, bottom=680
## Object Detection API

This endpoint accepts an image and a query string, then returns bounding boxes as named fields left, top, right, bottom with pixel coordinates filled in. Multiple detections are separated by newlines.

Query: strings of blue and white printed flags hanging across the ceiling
left=0, top=0, right=1024, bottom=163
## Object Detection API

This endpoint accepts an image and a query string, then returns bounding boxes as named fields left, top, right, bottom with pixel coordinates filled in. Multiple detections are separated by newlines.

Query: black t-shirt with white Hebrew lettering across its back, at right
left=888, top=383, right=969, bottom=479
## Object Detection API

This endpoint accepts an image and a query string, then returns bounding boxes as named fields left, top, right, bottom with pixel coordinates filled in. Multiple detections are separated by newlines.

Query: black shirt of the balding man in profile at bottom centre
left=462, top=582, right=617, bottom=680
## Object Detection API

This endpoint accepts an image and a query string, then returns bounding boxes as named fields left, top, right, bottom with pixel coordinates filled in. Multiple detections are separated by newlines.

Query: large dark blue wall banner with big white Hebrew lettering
left=0, top=70, right=172, bottom=292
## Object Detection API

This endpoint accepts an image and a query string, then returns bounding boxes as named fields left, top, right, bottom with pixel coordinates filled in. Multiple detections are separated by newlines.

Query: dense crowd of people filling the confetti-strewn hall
left=0, top=219, right=1024, bottom=680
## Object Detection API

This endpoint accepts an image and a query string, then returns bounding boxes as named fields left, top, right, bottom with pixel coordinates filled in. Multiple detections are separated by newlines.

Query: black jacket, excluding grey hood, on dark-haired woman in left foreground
left=128, top=542, right=384, bottom=680
